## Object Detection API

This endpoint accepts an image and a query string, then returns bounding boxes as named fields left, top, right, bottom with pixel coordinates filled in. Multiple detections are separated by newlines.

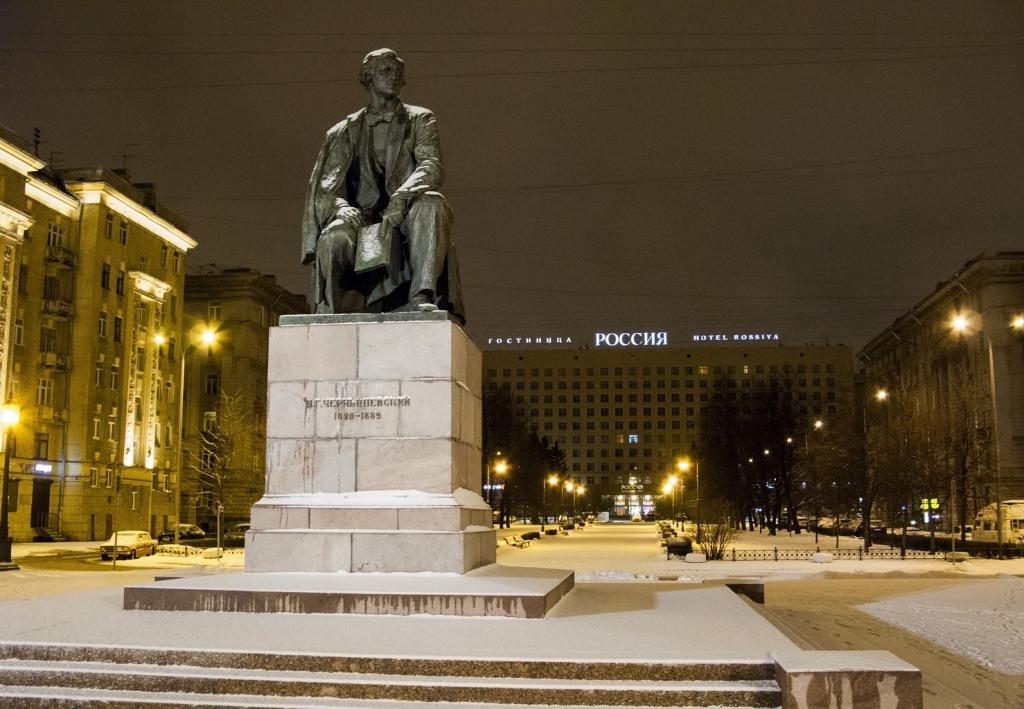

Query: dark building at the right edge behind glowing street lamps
left=857, top=251, right=1024, bottom=524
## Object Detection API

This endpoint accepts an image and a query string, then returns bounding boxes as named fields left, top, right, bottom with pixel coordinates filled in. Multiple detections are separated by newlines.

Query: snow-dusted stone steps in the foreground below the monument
left=0, top=643, right=781, bottom=707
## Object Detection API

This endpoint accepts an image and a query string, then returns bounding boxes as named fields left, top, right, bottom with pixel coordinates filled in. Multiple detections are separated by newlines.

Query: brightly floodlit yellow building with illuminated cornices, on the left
left=0, top=124, right=196, bottom=541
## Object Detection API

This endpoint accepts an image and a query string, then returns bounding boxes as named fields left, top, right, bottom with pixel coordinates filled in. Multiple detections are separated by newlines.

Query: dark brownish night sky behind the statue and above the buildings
left=0, top=0, right=1024, bottom=347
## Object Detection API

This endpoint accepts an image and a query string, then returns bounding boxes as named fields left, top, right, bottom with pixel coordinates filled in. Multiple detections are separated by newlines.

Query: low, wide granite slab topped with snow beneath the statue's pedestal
left=124, top=565, right=574, bottom=618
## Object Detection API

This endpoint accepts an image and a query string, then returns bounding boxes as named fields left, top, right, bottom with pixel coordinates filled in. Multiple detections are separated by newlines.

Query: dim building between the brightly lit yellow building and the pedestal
left=181, top=268, right=309, bottom=532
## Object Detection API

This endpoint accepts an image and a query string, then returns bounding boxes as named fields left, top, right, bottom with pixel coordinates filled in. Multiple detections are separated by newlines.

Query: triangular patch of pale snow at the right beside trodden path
left=859, top=576, right=1024, bottom=675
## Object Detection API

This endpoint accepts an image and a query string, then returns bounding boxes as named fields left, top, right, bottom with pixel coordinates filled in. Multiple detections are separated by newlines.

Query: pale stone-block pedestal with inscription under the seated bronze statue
left=246, top=310, right=495, bottom=574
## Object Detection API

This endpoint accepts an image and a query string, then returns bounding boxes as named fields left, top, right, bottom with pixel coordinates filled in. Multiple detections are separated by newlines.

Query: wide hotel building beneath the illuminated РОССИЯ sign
left=483, top=336, right=853, bottom=516
